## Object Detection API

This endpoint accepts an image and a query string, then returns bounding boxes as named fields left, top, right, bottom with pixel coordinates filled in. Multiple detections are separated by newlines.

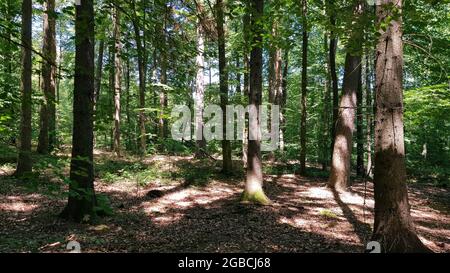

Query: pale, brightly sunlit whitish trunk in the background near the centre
left=195, top=11, right=206, bottom=158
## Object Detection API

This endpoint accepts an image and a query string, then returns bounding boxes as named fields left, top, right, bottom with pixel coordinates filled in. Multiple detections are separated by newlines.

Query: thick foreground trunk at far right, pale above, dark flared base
left=372, top=0, right=429, bottom=252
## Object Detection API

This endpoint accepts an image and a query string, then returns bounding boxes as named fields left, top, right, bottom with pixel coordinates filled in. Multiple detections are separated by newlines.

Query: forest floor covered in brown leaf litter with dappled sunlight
left=0, top=151, right=450, bottom=252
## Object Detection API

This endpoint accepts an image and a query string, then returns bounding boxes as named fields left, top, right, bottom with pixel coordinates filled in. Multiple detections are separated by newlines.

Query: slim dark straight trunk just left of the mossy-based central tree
left=216, top=0, right=233, bottom=173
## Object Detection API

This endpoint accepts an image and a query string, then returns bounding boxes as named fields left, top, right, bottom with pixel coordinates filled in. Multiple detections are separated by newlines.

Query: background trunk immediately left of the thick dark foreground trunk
left=37, top=0, right=56, bottom=154
